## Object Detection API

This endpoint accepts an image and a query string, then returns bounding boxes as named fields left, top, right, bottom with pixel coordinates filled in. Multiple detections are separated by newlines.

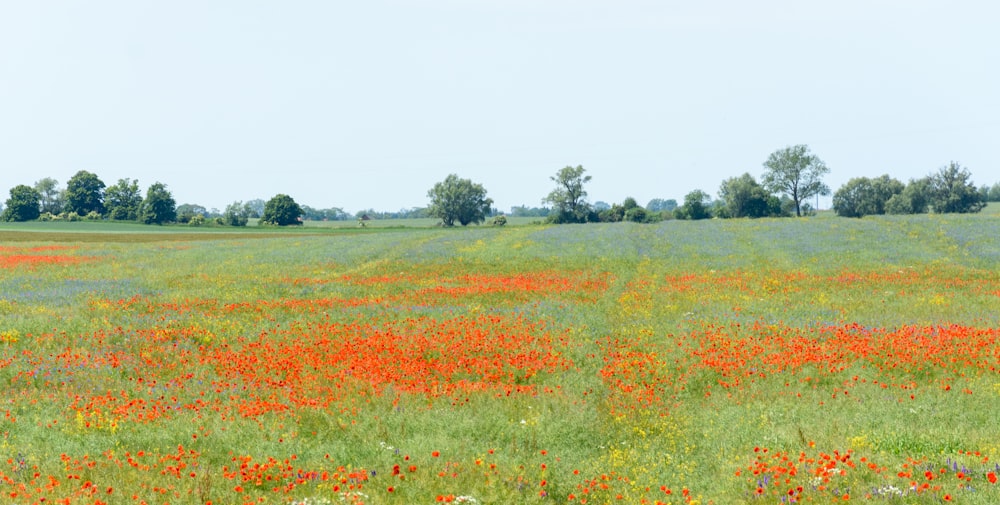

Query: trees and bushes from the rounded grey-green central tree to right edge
left=427, top=145, right=1000, bottom=226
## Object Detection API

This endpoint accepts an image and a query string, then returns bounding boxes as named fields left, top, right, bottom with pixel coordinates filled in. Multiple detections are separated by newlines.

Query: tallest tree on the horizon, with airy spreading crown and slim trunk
left=763, top=144, right=830, bottom=217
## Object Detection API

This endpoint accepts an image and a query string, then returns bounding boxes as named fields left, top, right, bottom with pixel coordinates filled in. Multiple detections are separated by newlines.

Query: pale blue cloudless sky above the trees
left=0, top=0, right=1000, bottom=212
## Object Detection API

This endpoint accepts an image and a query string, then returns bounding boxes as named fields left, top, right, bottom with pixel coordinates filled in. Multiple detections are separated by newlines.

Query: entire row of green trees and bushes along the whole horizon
left=0, top=145, right=1000, bottom=226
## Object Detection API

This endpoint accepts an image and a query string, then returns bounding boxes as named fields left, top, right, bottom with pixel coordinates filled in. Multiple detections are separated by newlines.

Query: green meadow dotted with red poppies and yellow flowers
left=0, top=209, right=1000, bottom=505
